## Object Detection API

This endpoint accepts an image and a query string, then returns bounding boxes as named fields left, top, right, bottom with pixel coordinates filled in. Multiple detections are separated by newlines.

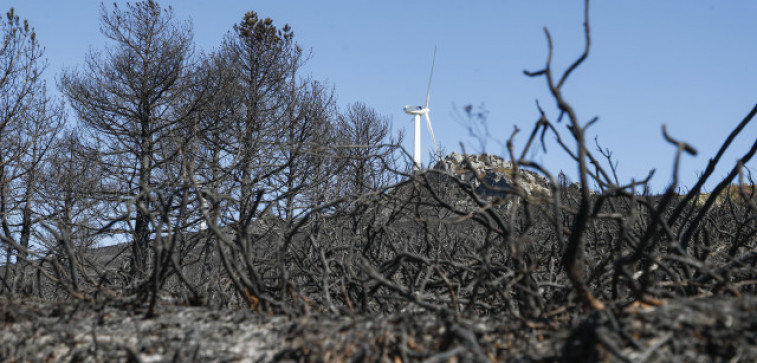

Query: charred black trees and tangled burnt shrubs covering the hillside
left=0, top=1, right=757, bottom=361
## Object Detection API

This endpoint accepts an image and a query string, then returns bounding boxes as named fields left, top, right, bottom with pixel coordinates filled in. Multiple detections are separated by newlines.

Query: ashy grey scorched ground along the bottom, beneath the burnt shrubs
left=0, top=296, right=757, bottom=362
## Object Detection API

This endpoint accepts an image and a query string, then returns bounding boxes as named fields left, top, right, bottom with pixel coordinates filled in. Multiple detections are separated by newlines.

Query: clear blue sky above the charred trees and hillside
left=7, top=0, right=757, bottom=191
